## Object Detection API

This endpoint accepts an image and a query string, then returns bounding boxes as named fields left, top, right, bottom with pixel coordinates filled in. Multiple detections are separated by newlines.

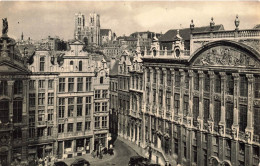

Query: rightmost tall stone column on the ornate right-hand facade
left=246, top=74, right=254, bottom=143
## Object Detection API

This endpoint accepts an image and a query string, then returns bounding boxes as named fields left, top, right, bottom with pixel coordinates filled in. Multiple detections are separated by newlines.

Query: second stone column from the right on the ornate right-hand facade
left=232, top=73, right=240, bottom=140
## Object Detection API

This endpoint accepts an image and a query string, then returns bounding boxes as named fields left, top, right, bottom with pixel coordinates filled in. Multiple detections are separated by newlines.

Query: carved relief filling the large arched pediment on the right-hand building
left=194, top=46, right=260, bottom=68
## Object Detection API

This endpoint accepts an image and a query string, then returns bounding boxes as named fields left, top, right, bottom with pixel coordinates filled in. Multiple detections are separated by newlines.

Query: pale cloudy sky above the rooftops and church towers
left=0, top=0, right=260, bottom=40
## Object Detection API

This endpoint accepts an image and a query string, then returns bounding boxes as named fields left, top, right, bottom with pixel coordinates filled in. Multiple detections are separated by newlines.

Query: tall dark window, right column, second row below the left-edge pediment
left=13, top=99, right=23, bottom=123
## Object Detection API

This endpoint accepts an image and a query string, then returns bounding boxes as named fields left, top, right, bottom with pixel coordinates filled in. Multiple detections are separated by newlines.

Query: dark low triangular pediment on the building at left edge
left=0, top=62, right=28, bottom=73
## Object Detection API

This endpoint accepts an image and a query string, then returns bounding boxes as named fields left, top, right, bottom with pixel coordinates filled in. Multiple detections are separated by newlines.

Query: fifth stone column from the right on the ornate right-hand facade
left=198, top=71, right=205, bottom=130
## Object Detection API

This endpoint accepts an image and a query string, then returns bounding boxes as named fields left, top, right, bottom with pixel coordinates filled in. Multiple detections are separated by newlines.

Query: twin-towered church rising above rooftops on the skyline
left=74, top=12, right=101, bottom=45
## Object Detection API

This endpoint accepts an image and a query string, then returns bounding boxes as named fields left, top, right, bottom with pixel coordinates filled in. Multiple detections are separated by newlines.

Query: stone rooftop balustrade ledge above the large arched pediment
left=191, top=29, right=260, bottom=39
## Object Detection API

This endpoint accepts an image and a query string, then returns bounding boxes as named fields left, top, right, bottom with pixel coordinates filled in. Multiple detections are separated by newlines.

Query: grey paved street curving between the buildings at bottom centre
left=90, top=139, right=138, bottom=166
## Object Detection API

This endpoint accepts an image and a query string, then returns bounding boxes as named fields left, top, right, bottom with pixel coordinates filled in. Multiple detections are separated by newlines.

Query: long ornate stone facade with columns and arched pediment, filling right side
left=115, top=19, right=260, bottom=166
